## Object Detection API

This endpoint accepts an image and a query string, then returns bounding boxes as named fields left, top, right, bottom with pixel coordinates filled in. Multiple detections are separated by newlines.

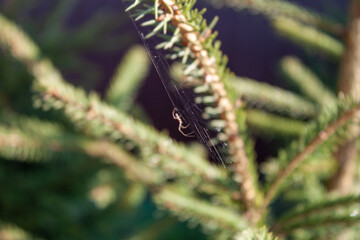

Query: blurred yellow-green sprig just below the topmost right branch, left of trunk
left=272, top=17, right=344, bottom=60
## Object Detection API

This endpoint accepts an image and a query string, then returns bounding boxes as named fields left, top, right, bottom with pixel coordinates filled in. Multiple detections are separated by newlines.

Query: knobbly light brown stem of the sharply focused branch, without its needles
left=160, top=0, right=256, bottom=206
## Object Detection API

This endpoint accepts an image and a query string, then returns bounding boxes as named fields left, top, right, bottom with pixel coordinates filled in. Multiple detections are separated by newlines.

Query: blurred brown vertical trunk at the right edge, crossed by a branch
left=329, top=0, right=360, bottom=194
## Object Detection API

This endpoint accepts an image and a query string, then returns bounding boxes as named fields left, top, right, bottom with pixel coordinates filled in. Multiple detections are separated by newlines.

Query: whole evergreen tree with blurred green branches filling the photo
left=0, top=0, right=360, bottom=240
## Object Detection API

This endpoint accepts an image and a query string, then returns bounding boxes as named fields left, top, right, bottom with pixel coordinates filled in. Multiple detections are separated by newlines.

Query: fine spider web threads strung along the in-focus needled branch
left=123, top=1, right=227, bottom=168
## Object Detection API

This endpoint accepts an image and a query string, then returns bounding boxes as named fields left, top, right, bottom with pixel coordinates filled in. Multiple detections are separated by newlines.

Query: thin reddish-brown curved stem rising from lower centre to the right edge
left=261, top=104, right=360, bottom=211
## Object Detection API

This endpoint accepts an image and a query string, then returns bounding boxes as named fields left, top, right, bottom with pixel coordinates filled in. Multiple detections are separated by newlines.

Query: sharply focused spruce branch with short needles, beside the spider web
left=127, top=0, right=259, bottom=206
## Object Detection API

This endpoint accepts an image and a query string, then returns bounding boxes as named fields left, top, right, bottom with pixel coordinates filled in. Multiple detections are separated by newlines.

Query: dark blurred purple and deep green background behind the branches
left=0, top=0, right=348, bottom=239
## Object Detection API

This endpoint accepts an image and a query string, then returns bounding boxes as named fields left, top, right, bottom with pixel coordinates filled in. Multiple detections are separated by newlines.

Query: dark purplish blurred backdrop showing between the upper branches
left=0, top=0, right=348, bottom=140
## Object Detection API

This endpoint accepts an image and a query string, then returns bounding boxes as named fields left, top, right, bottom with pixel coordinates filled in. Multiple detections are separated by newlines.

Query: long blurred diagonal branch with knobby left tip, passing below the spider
left=32, top=61, right=223, bottom=181
